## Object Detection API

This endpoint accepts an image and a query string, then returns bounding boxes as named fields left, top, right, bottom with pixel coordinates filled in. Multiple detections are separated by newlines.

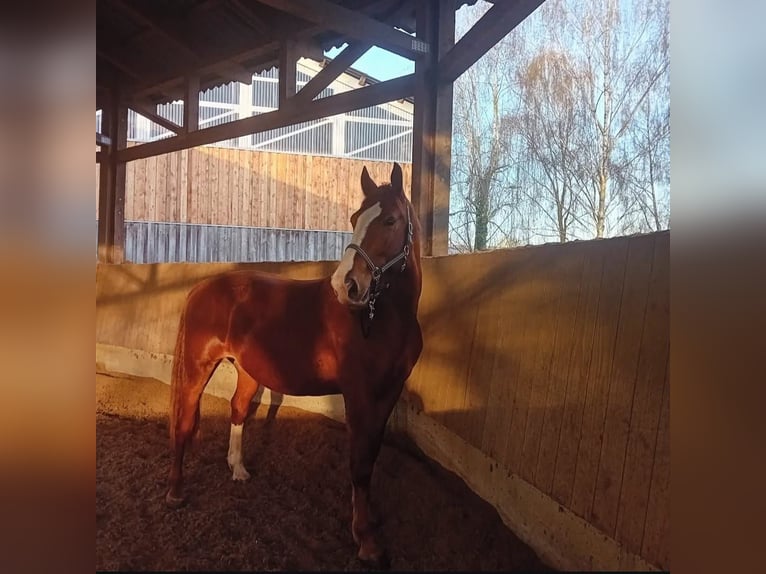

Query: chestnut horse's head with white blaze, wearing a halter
left=332, top=163, right=415, bottom=308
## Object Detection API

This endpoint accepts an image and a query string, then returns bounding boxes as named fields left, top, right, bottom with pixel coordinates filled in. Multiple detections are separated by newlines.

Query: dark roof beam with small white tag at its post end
left=258, top=0, right=430, bottom=60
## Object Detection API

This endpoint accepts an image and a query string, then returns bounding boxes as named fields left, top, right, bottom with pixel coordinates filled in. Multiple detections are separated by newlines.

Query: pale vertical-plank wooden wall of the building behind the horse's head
left=101, top=146, right=412, bottom=231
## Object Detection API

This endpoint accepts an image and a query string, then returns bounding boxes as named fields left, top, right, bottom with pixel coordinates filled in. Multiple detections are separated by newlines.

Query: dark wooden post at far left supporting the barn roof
left=98, top=88, right=128, bottom=263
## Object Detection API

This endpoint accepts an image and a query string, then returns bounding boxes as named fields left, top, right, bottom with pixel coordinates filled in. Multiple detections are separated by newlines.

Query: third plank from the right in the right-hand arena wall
left=570, top=238, right=629, bottom=519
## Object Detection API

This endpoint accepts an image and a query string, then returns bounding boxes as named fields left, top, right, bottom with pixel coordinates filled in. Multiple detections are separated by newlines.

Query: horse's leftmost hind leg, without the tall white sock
left=165, top=361, right=218, bottom=507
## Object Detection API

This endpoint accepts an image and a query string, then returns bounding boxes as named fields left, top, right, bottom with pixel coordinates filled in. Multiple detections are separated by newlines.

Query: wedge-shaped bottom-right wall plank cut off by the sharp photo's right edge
left=641, top=359, right=670, bottom=570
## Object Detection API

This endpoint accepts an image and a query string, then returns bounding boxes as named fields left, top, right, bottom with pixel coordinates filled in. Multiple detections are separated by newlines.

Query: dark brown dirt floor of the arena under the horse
left=96, top=374, right=546, bottom=571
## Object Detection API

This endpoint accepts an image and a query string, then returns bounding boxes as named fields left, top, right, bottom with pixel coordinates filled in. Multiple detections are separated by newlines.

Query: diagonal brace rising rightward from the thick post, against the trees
left=439, top=0, right=545, bottom=84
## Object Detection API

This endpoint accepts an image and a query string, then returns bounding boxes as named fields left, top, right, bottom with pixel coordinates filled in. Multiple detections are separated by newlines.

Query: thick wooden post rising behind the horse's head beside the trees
left=412, top=0, right=455, bottom=255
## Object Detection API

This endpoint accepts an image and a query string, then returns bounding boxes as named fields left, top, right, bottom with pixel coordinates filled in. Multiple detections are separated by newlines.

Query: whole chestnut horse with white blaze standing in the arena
left=166, top=163, right=423, bottom=565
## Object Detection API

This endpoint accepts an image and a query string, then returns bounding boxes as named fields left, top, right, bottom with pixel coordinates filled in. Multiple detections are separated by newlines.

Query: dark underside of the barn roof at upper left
left=96, top=0, right=486, bottom=107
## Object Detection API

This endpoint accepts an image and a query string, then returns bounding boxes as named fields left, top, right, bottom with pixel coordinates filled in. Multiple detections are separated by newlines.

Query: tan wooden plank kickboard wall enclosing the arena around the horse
left=96, top=232, right=670, bottom=569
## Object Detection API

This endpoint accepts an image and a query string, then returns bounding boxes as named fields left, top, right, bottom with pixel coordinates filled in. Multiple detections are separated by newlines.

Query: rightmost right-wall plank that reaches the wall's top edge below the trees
left=615, top=235, right=670, bottom=554
